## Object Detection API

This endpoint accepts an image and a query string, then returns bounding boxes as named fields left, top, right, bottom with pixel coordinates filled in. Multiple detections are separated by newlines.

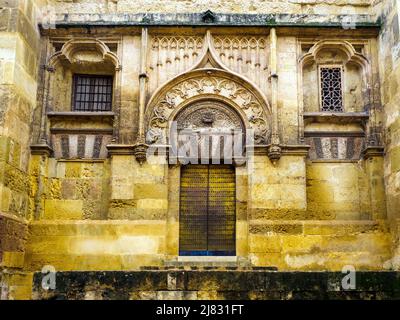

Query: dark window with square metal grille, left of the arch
left=72, top=74, right=113, bottom=111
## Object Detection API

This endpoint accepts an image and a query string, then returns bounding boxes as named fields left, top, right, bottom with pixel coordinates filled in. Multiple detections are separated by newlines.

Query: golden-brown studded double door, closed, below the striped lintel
left=180, top=165, right=236, bottom=255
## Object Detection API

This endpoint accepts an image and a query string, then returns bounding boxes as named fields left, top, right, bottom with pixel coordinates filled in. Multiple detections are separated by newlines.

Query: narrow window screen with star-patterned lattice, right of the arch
left=320, top=67, right=343, bottom=112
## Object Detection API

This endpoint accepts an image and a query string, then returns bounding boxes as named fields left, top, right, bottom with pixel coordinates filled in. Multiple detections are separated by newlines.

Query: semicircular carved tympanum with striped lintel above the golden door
left=167, top=97, right=249, bottom=164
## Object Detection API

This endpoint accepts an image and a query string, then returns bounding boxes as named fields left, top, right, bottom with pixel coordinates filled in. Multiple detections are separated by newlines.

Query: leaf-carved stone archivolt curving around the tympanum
left=146, top=75, right=270, bottom=145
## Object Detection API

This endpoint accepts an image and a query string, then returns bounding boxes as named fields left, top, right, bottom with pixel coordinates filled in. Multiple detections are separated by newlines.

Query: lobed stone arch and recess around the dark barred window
left=42, top=38, right=122, bottom=142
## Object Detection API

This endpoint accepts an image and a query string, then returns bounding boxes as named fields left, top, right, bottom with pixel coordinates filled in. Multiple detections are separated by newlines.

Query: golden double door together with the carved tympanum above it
left=170, top=100, right=245, bottom=256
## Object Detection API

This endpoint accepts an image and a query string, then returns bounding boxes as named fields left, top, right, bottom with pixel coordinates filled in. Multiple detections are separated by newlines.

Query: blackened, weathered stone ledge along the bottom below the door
left=33, top=269, right=400, bottom=300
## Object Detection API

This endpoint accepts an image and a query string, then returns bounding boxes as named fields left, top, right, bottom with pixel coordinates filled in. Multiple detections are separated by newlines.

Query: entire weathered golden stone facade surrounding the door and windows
left=0, top=0, right=400, bottom=299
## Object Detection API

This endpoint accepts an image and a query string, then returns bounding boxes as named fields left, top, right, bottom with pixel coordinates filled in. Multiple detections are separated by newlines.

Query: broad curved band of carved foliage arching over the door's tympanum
left=145, top=68, right=272, bottom=145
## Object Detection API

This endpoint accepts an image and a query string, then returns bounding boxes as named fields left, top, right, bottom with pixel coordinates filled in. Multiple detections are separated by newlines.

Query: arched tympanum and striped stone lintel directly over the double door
left=169, top=100, right=246, bottom=164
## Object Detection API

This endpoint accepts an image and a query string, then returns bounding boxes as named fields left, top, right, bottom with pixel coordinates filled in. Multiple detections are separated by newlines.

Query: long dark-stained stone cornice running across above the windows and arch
left=40, top=13, right=381, bottom=32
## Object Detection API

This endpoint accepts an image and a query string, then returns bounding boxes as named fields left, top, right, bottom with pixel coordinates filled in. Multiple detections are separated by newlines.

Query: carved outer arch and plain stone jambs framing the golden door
left=143, top=67, right=272, bottom=263
